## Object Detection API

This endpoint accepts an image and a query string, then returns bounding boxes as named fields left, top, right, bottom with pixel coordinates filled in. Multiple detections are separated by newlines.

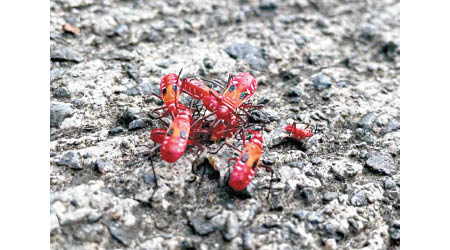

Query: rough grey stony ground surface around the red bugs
left=50, top=0, right=400, bottom=249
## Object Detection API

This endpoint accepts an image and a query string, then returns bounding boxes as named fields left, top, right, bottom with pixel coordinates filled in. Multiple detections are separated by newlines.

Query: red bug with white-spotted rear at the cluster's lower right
left=229, top=130, right=263, bottom=191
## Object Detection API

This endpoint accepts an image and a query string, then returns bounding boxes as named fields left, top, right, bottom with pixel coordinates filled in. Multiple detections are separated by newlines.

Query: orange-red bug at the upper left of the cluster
left=152, top=69, right=187, bottom=118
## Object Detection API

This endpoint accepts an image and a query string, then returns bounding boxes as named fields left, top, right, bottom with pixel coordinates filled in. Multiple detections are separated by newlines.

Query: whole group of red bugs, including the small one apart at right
left=150, top=71, right=313, bottom=194
